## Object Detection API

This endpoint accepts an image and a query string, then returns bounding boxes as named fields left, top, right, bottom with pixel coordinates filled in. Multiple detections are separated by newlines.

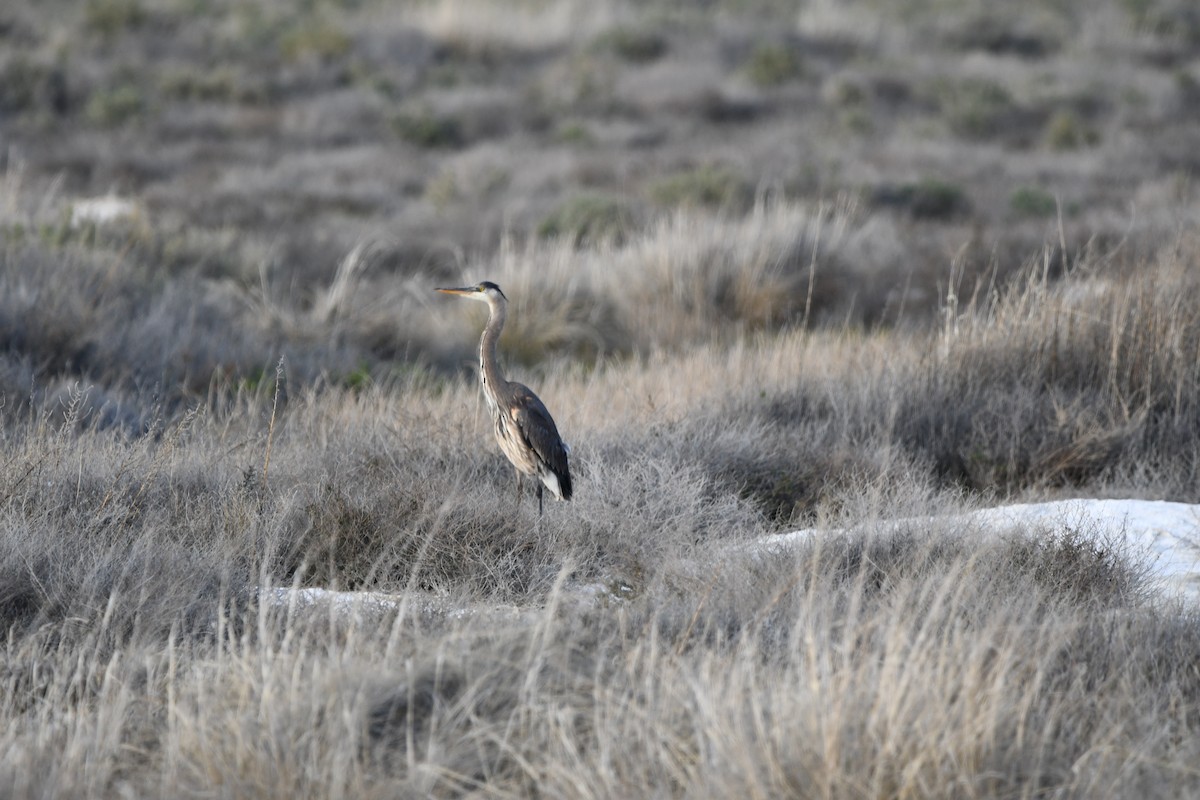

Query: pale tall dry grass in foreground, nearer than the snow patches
left=0, top=501, right=1200, bottom=798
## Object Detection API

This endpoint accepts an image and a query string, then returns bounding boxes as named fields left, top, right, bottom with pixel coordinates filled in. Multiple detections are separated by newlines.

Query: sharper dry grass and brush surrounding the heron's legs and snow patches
left=0, top=225, right=1200, bottom=798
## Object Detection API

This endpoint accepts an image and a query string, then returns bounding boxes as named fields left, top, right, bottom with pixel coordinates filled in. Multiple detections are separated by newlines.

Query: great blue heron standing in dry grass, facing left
left=438, top=281, right=571, bottom=515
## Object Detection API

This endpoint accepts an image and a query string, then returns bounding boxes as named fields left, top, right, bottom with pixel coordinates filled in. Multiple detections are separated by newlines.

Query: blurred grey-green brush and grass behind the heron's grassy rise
left=0, top=0, right=1200, bottom=420
